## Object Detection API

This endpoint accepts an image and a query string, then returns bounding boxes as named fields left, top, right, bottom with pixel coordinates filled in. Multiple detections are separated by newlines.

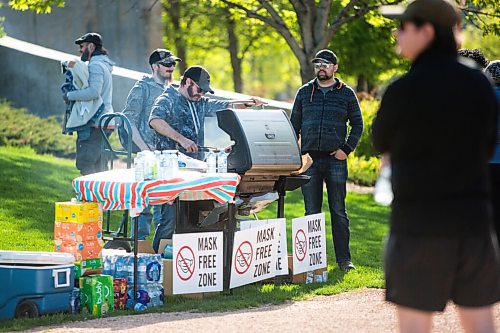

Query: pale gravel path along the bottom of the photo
left=26, top=289, right=500, bottom=333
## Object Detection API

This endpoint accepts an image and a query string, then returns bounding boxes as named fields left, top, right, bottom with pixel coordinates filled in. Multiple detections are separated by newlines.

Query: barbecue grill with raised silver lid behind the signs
left=176, top=109, right=309, bottom=290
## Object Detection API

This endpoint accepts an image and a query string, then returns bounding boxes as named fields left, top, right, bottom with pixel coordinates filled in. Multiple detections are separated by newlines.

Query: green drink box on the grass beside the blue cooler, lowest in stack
left=80, top=275, right=114, bottom=316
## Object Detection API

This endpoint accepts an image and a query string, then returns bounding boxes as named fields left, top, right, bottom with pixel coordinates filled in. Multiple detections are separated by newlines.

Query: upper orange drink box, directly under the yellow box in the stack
left=54, top=221, right=102, bottom=242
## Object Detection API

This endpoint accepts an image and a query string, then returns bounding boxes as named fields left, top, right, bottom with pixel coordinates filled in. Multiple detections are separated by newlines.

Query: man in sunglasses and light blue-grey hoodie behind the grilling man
left=118, top=49, right=182, bottom=240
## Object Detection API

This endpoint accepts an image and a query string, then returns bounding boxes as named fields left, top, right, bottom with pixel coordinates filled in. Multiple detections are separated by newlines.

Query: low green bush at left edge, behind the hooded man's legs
left=0, top=101, right=76, bottom=158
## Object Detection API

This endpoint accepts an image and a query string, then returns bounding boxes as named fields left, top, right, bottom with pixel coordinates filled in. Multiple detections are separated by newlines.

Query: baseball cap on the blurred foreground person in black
left=380, top=0, right=460, bottom=28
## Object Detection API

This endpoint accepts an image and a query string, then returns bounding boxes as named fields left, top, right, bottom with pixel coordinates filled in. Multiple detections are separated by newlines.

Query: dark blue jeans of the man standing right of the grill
left=302, top=156, right=351, bottom=263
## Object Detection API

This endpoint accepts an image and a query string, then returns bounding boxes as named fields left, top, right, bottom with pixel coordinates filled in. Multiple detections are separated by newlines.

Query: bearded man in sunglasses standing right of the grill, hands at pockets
left=290, top=50, right=363, bottom=271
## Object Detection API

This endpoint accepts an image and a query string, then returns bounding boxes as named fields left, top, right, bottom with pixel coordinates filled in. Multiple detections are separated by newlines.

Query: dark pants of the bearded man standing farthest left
left=76, top=127, right=110, bottom=176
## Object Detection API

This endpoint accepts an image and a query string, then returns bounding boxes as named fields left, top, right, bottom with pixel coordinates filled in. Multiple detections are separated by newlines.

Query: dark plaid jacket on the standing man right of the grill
left=290, top=79, right=363, bottom=154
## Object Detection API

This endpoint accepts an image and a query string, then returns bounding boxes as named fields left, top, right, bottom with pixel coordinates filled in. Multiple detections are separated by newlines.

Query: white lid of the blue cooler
left=0, top=250, right=75, bottom=265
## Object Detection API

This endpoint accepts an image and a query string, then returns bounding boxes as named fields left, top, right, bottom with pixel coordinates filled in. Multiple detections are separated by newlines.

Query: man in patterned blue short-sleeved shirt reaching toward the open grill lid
left=149, top=66, right=264, bottom=252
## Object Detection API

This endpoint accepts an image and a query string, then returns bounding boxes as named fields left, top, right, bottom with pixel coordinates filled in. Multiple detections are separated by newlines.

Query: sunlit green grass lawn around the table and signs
left=0, top=147, right=388, bottom=331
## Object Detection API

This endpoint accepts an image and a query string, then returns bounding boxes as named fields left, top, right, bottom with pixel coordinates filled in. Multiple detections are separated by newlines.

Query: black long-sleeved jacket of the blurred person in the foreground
left=372, top=51, right=497, bottom=236
